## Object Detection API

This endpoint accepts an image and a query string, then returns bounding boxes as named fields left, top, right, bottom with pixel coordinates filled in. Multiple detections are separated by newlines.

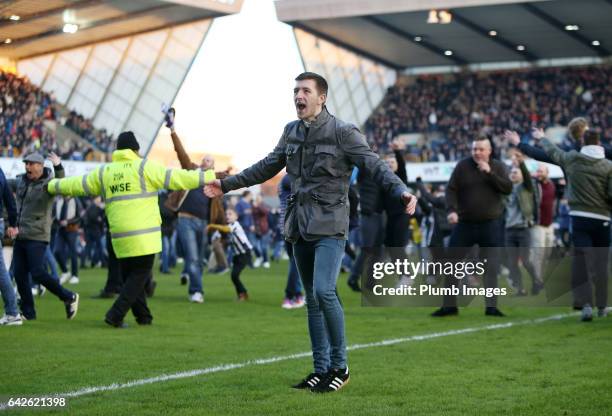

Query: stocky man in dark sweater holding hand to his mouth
left=432, top=136, right=512, bottom=317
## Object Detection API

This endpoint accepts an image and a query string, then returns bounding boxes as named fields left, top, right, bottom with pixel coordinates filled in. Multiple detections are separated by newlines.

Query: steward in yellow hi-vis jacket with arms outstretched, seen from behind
left=48, top=131, right=215, bottom=327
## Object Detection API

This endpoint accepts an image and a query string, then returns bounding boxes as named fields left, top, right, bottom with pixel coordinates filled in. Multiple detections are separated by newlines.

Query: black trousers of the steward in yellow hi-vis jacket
left=106, top=254, right=155, bottom=324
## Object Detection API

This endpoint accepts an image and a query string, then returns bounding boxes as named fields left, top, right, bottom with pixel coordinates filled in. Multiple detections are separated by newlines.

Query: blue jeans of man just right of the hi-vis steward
left=176, top=217, right=208, bottom=294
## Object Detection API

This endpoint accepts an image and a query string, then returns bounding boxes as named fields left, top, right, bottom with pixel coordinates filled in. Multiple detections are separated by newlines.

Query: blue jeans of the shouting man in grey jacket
left=293, top=238, right=346, bottom=373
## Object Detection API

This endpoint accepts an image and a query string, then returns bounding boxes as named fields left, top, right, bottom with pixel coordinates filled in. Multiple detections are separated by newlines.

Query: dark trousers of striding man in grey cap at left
left=12, top=240, right=74, bottom=320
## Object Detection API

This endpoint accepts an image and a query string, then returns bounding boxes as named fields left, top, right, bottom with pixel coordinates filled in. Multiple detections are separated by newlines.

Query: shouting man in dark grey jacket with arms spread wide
left=205, top=72, right=417, bottom=393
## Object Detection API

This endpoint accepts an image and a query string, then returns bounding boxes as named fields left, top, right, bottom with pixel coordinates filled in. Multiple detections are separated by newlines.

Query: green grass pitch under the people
left=0, top=262, right=612, bottom=416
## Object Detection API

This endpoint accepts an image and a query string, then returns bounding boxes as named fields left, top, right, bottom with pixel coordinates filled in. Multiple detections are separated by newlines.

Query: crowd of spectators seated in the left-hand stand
left=0, top=70, right=113, bottom=160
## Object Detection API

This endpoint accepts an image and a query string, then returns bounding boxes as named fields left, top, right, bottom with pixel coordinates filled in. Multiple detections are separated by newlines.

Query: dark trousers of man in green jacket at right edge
left=571, top=216, right=610, bottom=308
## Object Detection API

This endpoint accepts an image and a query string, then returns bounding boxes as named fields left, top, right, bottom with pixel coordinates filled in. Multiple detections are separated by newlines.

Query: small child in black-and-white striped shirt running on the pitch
left=206, top=208, right=253, bottom=302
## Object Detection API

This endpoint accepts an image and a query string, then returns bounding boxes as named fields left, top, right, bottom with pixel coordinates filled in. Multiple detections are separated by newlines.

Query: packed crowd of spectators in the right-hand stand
left=365, top=65, right=612, bottom=162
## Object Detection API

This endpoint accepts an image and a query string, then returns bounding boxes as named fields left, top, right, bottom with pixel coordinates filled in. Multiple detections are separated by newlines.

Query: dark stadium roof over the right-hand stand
left=276, top=0, right=612, bottom=69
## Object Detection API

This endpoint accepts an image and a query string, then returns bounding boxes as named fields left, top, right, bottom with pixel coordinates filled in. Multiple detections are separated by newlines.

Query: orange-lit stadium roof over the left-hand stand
left=0, top=0, right=243, bottom=59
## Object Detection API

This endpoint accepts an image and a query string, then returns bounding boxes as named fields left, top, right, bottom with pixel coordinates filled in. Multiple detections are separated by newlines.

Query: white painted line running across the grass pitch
left=0, top=313, right=576, bottom=411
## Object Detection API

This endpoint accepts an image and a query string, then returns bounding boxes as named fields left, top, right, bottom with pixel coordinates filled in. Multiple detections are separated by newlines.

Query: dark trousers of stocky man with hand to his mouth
left=443, top=219, right=504, bottom=307
